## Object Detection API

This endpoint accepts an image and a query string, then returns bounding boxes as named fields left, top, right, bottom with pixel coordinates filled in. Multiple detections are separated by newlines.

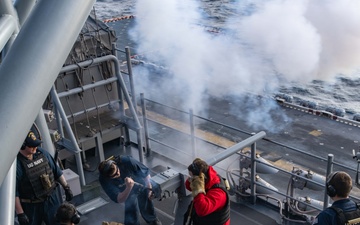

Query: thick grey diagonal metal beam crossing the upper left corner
left=0, top=0, right=95, bottom=184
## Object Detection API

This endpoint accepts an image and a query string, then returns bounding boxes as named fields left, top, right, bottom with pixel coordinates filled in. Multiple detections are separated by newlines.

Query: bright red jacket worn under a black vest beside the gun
left=185, top=166, right=230, bottom=225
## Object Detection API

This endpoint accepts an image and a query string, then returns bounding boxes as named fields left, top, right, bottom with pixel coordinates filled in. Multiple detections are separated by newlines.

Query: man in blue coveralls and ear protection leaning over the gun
left=98, top=155, right=162, bottom=225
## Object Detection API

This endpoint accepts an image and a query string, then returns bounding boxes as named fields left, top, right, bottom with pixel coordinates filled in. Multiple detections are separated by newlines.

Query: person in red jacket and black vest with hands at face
left=184, top=158, right=230, bottom=225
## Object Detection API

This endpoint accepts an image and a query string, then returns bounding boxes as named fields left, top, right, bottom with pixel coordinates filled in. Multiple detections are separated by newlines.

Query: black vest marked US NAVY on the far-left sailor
left=18, top=153, right=56, bottom=200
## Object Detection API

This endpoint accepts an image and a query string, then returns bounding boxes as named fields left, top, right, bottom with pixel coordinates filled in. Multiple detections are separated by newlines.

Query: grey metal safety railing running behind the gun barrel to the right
left=141, top=94, right=359, bottom=224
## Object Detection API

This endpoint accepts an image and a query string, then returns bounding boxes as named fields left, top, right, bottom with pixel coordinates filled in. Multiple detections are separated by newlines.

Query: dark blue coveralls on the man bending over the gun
left=99, top=156, right=157, bottom=225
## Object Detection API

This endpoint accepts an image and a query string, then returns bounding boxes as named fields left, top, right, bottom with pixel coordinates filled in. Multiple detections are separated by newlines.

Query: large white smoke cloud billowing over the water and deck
left=131, top=0, right=360, bottom=132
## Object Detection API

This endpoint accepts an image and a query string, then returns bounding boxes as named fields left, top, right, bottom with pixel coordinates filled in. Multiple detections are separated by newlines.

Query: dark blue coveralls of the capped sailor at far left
left=16, top=147, right=63, bottom=225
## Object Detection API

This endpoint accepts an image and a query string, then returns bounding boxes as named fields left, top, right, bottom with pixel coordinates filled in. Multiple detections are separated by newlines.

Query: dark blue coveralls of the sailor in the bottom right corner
left=313, top=199, right=357, bottom=225
